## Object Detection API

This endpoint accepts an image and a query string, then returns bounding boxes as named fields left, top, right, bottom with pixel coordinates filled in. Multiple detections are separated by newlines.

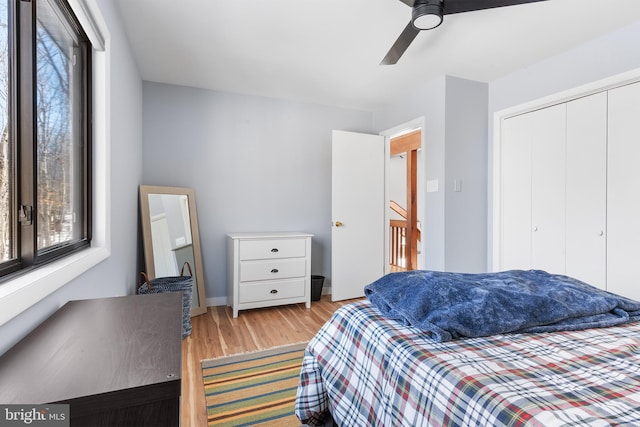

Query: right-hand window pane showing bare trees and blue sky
left=36, top=1, right=82, bottom=250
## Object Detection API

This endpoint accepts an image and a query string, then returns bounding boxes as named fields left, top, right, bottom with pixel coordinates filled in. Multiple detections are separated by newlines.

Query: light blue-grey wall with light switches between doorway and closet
left=374, top=76, right=488, bottom=272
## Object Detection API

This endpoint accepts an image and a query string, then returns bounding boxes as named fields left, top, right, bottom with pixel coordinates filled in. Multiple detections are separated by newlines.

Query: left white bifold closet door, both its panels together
left=501, top=104, right=566, bottom=274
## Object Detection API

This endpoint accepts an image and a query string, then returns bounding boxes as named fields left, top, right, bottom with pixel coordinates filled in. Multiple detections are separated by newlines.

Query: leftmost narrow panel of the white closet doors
left=501, top=114, right=532, bottom=270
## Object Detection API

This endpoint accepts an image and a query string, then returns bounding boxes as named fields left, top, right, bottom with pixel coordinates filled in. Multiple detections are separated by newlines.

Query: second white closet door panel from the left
left=530, top=104, right=566, bottom=274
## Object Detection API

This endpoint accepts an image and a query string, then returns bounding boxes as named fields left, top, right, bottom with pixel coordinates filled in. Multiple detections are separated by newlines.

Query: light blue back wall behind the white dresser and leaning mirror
left=143, top=82, right=372, bottom=305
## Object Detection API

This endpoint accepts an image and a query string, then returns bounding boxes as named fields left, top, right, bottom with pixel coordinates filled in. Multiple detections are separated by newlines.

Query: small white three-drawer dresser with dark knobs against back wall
left=227, top=232, right=313, bottom=317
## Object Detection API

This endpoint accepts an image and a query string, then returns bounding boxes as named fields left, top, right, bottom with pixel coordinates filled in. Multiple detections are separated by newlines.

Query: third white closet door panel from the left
left=566, top=92, right=607, bottom=289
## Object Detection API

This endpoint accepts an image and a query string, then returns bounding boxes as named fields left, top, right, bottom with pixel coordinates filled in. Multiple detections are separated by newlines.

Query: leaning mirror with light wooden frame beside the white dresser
left=140, top=185, right=207, bottom=317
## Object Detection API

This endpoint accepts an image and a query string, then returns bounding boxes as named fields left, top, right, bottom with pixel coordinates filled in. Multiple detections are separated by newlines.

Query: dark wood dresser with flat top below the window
left=0, top=293, right=182, bottom=427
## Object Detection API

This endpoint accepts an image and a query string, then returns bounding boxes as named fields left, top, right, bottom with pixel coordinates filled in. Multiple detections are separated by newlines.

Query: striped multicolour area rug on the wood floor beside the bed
left=202, top=343, right=307, bottom=427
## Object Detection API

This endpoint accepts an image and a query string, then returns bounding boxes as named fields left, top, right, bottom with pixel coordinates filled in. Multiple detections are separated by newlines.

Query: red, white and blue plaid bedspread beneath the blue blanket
left=295, top=301, right=640, bottom=427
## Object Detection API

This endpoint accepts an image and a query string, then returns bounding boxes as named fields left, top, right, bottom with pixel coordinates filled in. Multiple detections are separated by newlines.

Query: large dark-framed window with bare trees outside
left=0, top=0, right=91, bottom=276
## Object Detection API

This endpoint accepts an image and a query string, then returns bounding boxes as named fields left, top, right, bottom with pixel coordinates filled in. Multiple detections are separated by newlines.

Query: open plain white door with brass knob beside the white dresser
left=331, top=130, right=385, bottom=301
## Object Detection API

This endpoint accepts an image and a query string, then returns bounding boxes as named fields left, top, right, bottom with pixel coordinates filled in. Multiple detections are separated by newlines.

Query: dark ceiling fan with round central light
left=380, top=0, right=545, bottom=65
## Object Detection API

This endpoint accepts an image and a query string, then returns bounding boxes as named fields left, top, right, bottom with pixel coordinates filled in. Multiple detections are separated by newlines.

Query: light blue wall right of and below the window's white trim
left=0, top=0, right=142, bottom=354
